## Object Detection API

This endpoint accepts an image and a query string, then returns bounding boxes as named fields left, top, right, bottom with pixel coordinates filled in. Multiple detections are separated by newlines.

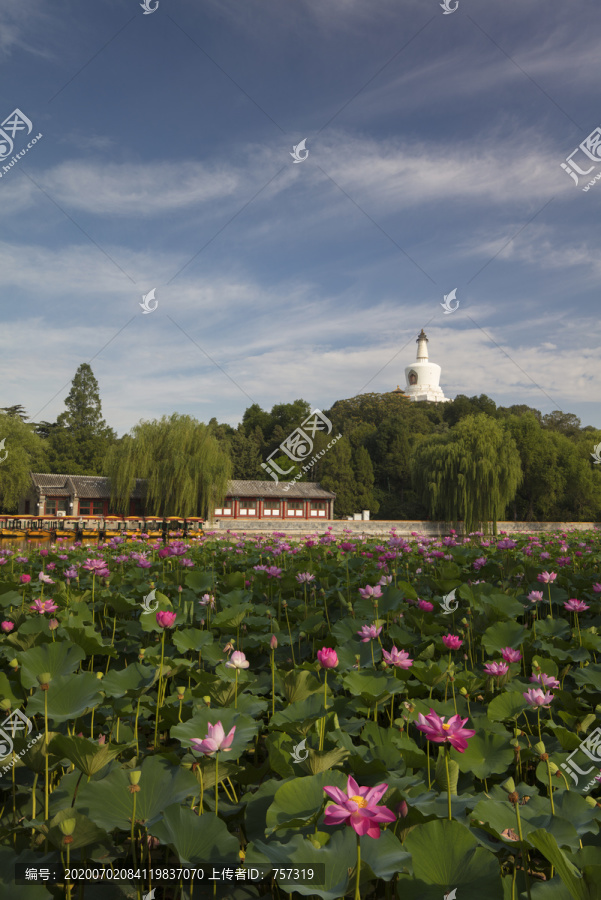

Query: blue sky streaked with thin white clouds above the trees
left=0, top=0, right=601, bottom=434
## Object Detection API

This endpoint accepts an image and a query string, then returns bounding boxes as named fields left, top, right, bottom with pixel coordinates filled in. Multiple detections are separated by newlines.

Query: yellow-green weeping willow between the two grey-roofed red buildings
left=105, top=413, right=232, bottom=518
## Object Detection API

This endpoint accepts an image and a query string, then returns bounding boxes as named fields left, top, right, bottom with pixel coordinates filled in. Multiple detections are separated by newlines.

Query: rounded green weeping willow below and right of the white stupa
left=412, top=414, right=522, bottom=534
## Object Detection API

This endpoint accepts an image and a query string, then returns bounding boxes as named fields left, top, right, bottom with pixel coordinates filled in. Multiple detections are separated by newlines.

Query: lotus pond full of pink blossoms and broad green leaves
left=0, top=532, right=601, bottom=900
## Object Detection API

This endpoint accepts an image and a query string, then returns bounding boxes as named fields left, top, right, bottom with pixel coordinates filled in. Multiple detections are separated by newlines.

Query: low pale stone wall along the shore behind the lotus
left=210, top=519, right=601, bottom=537
